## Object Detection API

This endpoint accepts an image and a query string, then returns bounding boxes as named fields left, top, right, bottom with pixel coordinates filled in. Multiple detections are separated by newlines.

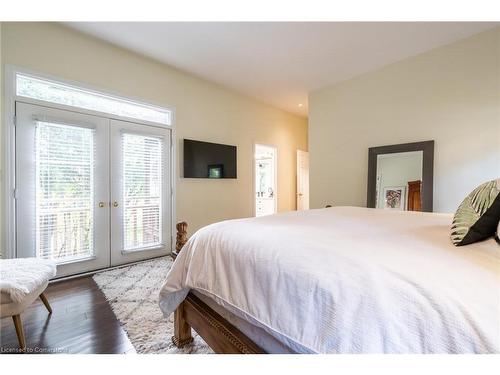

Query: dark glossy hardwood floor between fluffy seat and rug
left=0, top=276, right=135, bottom=354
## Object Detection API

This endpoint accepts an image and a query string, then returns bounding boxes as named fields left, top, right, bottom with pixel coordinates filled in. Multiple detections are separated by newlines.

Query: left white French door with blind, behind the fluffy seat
left=15, top=102, right=110, bottom=276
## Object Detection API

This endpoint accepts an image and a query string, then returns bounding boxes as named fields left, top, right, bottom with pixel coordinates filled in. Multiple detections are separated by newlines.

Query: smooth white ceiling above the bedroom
left=66, top=22, right=500, bottom=116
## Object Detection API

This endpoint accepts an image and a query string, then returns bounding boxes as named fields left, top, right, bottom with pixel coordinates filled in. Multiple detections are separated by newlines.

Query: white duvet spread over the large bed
left=160, top=207, right=500, bottom=353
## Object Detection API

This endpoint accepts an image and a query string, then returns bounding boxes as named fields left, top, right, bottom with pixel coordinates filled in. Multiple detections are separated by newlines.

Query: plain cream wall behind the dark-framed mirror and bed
left=309, top=28, right=500, bottom=212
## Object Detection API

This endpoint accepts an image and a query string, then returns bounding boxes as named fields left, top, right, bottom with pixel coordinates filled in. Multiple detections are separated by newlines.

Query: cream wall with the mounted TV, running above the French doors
left=2, top=23, right=307, bottom=244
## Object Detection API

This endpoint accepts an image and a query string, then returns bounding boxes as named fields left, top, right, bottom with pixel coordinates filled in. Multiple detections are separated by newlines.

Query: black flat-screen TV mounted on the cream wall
left=184, top=139, right=236, bottom=178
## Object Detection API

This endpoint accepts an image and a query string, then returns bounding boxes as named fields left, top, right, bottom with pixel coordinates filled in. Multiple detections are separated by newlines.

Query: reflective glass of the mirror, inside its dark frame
left=375, top=151, right=423, bottom=211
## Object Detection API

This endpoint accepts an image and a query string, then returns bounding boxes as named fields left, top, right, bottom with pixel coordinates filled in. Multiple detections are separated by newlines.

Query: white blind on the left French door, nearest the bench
left=35, top=122, right=95, bottom=262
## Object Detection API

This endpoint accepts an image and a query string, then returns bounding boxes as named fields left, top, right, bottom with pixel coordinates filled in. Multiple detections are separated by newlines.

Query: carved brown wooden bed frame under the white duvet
left=172, top=222, right=265, bottom=354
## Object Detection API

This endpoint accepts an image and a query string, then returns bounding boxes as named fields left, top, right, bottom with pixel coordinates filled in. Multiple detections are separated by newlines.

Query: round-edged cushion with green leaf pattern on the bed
left=451, top=179, right=500, bottom=246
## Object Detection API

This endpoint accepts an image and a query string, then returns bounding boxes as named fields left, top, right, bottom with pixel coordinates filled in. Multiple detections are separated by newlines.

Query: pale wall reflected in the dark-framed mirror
left=377, top=151, right=423, bottom=209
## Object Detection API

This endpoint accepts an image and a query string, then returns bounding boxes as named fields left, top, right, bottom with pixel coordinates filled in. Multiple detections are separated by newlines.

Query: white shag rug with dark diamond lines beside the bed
left=93, top=256, right=213, bottom=354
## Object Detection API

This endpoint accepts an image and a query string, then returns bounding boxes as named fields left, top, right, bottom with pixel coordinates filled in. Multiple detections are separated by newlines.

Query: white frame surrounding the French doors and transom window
left=0, top=64, right=178, bottom=259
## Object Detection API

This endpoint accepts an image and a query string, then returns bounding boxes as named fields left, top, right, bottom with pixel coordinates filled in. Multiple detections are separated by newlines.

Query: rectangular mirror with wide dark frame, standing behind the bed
left=367, top=141, right=434, bottom=212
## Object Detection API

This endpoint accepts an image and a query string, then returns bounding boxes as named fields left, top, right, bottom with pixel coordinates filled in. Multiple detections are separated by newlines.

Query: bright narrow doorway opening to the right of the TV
left=254, top=144, right=278, bottom=216
